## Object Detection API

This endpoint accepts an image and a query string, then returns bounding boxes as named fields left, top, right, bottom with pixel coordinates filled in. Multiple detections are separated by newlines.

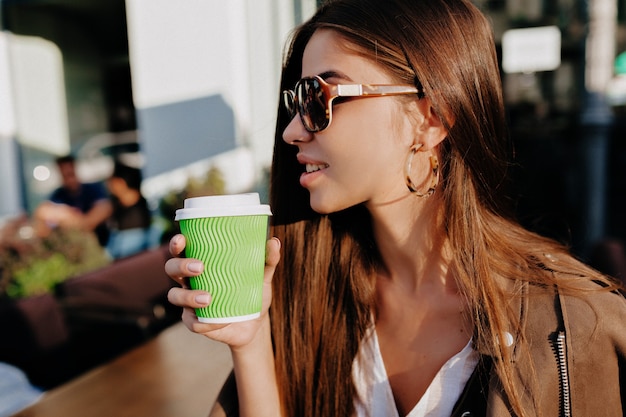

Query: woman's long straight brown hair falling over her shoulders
left=270, top=0, right=611, bottom=416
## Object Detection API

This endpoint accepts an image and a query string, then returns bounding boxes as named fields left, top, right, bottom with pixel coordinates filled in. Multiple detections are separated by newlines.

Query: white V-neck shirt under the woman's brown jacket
left=352, top=329, right=479, bottom=417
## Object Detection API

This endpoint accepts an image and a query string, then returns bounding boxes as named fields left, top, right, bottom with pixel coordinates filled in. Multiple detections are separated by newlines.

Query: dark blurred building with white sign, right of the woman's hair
left=480, top=0, right=626, bottom=257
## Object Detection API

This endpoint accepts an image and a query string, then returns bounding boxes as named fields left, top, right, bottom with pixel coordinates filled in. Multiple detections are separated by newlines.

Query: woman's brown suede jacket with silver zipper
left=452, top=282, right=626, bottom=417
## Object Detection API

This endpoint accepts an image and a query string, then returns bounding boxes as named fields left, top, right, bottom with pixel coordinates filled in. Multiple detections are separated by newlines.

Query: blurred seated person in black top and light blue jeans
left=107, top=161, right=152, bottom=259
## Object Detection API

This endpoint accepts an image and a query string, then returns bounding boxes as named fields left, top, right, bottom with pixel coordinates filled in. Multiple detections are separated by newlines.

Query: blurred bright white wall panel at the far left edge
left=0, top=32, right=70, bottom=218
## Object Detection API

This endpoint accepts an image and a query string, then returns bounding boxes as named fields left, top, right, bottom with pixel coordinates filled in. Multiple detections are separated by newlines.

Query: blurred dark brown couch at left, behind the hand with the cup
left=0, top=246, right=181, bottom=389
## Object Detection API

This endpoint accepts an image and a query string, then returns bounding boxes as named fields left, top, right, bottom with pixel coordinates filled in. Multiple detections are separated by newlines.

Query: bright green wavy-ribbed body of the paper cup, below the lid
left=180, top=215, right=268, bottom=319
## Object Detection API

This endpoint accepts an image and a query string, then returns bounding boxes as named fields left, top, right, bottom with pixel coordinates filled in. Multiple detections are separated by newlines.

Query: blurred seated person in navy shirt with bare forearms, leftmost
left=34, top=155, right=113, bottom=246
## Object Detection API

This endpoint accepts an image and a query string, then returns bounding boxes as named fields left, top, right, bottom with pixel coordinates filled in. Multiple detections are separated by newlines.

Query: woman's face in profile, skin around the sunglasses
left=283, top=30, right=414, bottom=213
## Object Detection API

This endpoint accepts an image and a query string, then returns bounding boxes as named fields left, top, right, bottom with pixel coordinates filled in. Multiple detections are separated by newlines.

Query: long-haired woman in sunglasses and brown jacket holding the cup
left=166, top=0, right=626, bottom=417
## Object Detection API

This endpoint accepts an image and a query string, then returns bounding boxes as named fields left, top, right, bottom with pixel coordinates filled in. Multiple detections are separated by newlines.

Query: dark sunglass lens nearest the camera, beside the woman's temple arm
left=296, top=78, right=328, bottom=132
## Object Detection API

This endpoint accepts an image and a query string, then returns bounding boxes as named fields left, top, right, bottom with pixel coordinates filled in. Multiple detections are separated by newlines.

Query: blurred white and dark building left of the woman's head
left=0, top=0, right=316, bottom=216
